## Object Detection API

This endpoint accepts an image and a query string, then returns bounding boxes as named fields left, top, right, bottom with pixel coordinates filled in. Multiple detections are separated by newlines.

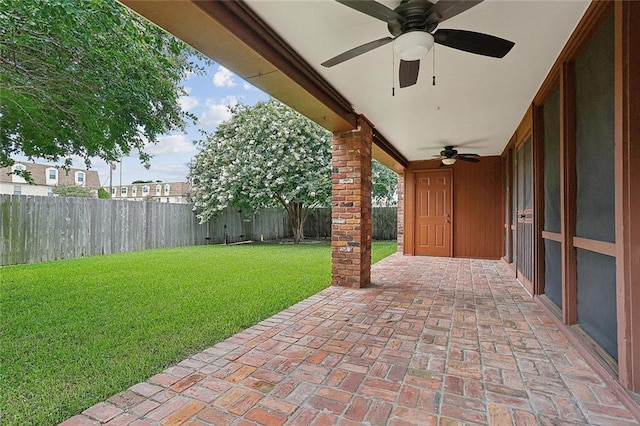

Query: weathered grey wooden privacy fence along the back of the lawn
left=0, top=195, right=396, bottom=266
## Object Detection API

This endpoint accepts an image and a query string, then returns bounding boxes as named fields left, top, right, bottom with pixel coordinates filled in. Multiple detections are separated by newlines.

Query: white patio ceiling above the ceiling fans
left=246, top=0, right=589, bottom=160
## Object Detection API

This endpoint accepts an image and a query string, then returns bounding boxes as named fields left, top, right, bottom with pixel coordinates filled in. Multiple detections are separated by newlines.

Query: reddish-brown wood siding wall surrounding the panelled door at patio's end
left=404, top=156, right=503, bottom=259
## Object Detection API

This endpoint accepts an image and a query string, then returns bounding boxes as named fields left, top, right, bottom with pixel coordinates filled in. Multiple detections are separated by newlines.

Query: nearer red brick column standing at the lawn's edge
left=331, top=118, right=372, bottom=288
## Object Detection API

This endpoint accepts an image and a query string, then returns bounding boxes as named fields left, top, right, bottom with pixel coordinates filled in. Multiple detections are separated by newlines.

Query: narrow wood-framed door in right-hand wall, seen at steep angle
left=515, top=136, right=534, bottom=294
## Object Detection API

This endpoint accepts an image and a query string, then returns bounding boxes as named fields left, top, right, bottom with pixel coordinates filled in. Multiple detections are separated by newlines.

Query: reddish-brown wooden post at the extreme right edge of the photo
left=614, top=1, right=640, bottom=392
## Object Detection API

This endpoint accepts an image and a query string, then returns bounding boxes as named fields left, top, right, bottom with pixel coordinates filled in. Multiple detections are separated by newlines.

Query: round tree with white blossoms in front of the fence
left=189, top=99, right=331, bottom=244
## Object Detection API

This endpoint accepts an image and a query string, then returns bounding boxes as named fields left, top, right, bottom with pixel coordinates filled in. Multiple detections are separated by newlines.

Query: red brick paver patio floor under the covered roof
left=64, top=254, right=639, bottom=426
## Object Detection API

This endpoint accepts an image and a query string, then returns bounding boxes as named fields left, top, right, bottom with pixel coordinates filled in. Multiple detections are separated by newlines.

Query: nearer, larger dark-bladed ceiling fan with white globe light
left=321, top=0, right=514, bottom=87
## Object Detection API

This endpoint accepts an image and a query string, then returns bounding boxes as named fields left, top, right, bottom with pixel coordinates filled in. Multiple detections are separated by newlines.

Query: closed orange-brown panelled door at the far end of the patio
left=415, top=170, right=453, bottom=256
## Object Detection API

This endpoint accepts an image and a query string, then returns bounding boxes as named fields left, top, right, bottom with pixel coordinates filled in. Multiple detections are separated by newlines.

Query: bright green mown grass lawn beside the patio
left=0, top=242, right=396, bottom=425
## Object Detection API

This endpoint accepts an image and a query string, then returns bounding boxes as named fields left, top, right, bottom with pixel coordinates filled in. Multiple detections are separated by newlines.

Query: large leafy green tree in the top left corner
left=0, top=0, right=204, bottom=171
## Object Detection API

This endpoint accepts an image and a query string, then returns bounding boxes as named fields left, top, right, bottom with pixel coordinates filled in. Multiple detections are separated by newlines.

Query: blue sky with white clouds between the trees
left=16, top=62, right=269, bottom=187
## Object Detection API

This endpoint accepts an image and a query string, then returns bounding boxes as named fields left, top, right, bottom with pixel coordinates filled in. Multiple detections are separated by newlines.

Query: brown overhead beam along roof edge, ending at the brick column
left=121, top=0, right=356, bottom=132
